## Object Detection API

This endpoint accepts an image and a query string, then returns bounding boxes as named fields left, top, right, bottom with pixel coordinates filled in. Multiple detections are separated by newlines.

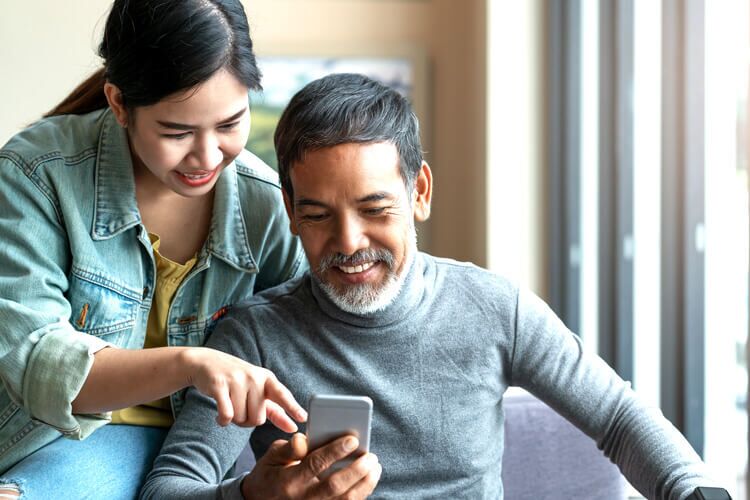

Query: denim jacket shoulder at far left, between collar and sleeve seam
left=0, top=110, right=108, bottom=165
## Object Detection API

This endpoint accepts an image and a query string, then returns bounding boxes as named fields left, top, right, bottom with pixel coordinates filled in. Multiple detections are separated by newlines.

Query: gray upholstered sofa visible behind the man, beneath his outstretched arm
left=235, top=388, right=629, bottom=500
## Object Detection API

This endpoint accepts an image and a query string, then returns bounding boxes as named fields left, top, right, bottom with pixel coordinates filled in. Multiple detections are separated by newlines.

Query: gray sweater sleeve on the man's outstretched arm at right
left=511, top=291, right=715, bottom=500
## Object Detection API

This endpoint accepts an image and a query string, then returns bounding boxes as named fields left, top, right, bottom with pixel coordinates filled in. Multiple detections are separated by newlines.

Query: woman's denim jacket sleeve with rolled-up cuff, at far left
left=0, top=152, right=109, bottom=439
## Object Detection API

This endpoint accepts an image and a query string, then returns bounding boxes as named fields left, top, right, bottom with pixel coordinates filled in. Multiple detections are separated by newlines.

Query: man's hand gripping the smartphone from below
left=242, top=434, right=383, bottom=500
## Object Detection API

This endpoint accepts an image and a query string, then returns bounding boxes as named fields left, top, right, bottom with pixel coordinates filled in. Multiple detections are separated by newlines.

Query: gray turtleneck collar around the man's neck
left=310, top=252, right=424, bottom=328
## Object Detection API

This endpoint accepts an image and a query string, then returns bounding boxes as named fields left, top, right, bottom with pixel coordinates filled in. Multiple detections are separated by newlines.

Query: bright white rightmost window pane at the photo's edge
left=702, top=0, right=750, bottom=499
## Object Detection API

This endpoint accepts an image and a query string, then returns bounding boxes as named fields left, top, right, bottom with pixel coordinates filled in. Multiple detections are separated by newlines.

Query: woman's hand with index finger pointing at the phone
left=182, top=347, right=307, bottom=432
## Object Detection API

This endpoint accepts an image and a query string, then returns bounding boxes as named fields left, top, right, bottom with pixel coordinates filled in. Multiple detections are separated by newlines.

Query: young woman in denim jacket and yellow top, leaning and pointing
left=0, top=0, right=306, bottom=498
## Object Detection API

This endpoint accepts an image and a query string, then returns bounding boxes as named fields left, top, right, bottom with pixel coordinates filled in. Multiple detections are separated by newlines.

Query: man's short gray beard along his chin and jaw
left=313, top=227, right=417, bottom=315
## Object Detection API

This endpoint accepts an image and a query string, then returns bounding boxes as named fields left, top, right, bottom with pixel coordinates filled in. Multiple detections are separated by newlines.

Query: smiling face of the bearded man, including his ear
left=285, top=142, right=431, bottom=314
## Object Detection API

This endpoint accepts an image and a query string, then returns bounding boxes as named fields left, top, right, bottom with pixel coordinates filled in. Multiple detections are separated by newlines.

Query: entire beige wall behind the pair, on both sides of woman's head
left=0, top=0, right=532, bottom=274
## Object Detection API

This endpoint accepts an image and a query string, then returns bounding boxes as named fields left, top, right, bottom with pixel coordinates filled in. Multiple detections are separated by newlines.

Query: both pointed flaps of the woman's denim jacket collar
left=91, top=110, right=257, bottom=272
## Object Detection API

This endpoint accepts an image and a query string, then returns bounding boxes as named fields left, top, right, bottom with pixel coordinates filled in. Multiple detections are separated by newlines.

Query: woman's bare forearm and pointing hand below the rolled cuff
left=72, top=347, right=307, bottom=432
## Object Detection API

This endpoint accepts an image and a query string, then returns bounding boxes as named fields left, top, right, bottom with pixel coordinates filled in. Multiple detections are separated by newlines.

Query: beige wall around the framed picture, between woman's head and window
left=250, top=0, right=486, bottom=264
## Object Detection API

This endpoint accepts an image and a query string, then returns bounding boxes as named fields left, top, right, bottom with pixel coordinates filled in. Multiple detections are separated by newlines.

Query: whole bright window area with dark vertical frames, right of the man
left=487, top=0, right=750, bottom=499
